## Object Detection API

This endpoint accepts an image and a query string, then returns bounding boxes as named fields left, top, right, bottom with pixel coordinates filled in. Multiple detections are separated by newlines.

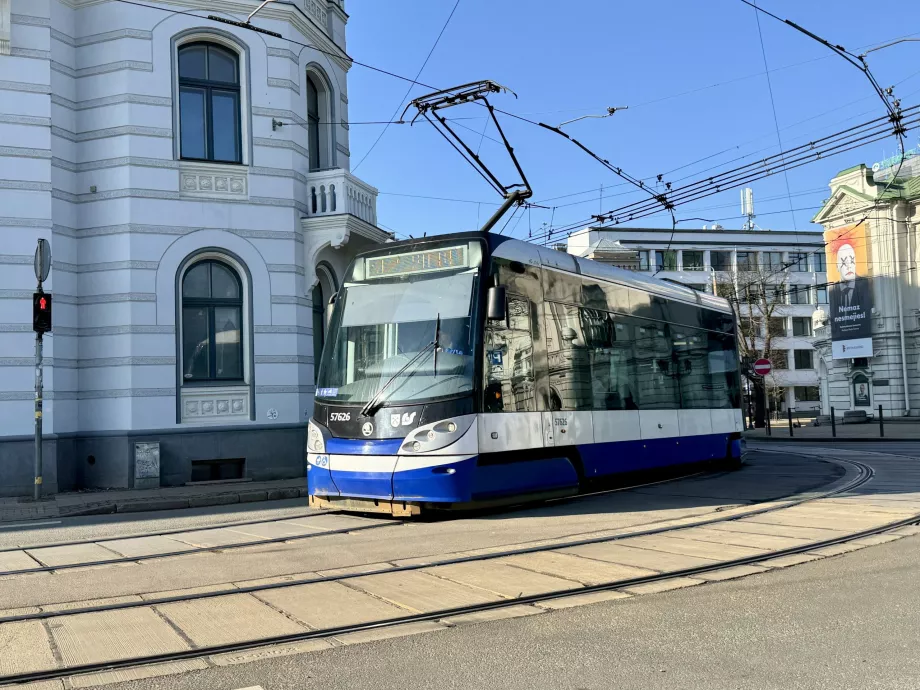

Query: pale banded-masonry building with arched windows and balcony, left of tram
left=0, top=0, right=388, bottom=496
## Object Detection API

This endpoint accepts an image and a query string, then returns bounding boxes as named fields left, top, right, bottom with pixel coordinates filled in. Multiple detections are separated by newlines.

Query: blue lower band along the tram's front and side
left=308, top=433, right=742, bottom=504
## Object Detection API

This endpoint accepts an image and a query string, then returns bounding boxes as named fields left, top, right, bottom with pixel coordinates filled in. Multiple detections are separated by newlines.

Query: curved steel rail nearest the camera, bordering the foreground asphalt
left=0, top=460, right=904, bottom=685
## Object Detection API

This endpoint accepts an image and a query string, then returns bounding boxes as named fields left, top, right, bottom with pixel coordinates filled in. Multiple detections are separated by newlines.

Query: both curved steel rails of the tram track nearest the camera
left=0, top=456, right=908, bottom=685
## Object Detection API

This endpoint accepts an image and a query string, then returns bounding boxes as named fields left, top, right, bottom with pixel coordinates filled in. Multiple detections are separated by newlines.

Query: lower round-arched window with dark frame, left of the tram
left=182, top=260, right=243, bottom=382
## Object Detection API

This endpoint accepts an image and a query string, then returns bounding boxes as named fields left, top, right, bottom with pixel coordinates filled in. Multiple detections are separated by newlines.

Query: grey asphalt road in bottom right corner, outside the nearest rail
left=100, top=537, right=920, bottom=690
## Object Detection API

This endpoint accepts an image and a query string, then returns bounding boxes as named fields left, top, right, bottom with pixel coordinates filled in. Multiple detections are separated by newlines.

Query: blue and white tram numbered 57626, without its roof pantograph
left=307, top=233, right=743, bottom=515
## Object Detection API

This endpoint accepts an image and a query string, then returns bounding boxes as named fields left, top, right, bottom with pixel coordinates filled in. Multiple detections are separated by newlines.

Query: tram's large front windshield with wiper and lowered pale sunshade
left=316, top=242, right=478, bottom=406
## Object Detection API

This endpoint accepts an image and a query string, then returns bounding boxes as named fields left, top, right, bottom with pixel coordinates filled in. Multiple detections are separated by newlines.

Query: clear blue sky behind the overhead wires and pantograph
left=347, top=0, right=920, bottom=238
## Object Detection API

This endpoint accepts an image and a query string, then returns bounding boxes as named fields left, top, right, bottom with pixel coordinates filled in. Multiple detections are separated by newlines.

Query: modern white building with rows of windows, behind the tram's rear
left=564, top=226, right=827, bottom=412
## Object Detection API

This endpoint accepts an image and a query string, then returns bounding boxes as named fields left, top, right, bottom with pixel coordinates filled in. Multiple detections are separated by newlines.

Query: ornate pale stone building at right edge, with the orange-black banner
left=814, top=164, right=920, bottom=416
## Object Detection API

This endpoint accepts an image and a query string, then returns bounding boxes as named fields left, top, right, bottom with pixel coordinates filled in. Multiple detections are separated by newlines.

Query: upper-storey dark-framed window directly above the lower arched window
left=179, top=43, right=242, bottom=163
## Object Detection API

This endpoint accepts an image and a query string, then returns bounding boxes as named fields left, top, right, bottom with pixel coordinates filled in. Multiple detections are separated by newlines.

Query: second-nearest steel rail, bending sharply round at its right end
left=0, top=453, right=874, bottom=624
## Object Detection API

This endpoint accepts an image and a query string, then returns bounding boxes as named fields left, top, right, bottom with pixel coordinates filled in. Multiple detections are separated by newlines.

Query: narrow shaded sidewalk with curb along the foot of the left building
left=0, top=478, right=307, bottom=523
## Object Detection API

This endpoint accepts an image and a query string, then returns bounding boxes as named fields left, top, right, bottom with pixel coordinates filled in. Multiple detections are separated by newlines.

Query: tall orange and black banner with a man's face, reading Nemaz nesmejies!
left=824, top=223, right=873, bottom=359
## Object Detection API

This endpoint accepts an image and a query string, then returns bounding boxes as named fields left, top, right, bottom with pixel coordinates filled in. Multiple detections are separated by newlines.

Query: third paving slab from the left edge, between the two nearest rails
left=157, top=594, right=306, bottom=647
